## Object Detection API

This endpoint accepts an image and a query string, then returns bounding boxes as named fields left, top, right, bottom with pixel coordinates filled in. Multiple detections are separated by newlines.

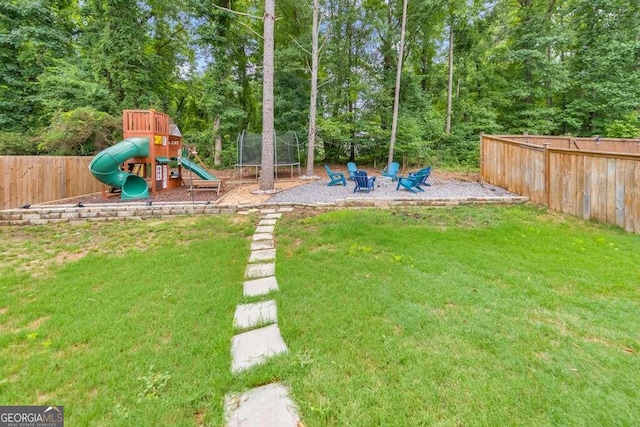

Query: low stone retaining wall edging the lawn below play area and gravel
left=0, top=197, right=528, bottom=226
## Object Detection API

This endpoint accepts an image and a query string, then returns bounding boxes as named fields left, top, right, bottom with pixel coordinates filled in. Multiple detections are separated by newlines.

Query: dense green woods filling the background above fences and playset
left=0, top=0, right=640, bottom=166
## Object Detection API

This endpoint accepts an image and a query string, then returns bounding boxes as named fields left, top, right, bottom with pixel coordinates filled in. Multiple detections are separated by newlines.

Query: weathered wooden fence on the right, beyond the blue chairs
left=480, top=135, right=640, bottom=233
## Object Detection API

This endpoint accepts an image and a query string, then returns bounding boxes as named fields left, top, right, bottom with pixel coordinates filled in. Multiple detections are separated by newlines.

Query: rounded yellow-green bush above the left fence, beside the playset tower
left=38, top=107, right=122, bottom=156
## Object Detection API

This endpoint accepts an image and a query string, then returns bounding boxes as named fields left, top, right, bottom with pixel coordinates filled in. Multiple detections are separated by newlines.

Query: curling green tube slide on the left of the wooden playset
left=89, top=138, right=149, bottom=200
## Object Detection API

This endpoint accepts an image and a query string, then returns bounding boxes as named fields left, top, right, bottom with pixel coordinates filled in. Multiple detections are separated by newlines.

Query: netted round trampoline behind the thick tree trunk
left=235, top=130, right=302, bottom=179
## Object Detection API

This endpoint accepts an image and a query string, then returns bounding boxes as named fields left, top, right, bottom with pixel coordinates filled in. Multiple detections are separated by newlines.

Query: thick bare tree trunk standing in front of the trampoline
left=260, top=0, right=276, bottom=191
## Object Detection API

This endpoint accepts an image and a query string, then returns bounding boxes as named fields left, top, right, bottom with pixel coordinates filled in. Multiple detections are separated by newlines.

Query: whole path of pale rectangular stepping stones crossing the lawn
left=225, top=208, right=302, bottom=427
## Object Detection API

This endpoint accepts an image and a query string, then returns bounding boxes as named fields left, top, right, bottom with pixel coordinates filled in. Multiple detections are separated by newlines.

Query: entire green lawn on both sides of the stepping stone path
left=0, top=206, right=640, bottom=426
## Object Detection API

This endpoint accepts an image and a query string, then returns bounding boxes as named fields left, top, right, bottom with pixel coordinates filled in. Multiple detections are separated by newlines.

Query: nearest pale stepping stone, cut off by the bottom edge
left=225, top=383, right=300, bottom=427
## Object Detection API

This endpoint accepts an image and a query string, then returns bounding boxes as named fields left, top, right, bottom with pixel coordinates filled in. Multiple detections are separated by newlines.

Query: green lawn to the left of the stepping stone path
left=0, top=216, right=256, bottom=426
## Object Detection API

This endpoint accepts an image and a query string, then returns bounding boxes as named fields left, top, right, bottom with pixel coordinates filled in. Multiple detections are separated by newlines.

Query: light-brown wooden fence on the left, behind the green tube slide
left=0, top=156, right=102, bottom=209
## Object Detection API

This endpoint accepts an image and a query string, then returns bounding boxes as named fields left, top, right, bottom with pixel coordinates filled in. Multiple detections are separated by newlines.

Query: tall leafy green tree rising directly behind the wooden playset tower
left=80, top=0, right=189, bottom=113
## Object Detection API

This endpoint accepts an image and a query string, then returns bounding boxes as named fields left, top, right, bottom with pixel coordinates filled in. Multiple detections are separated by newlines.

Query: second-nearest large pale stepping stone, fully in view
left=231, top=324, right=288, bottom=373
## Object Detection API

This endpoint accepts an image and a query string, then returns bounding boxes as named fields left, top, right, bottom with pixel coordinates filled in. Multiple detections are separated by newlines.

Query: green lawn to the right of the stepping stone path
left=272, top=206, right=640, bottom=426
